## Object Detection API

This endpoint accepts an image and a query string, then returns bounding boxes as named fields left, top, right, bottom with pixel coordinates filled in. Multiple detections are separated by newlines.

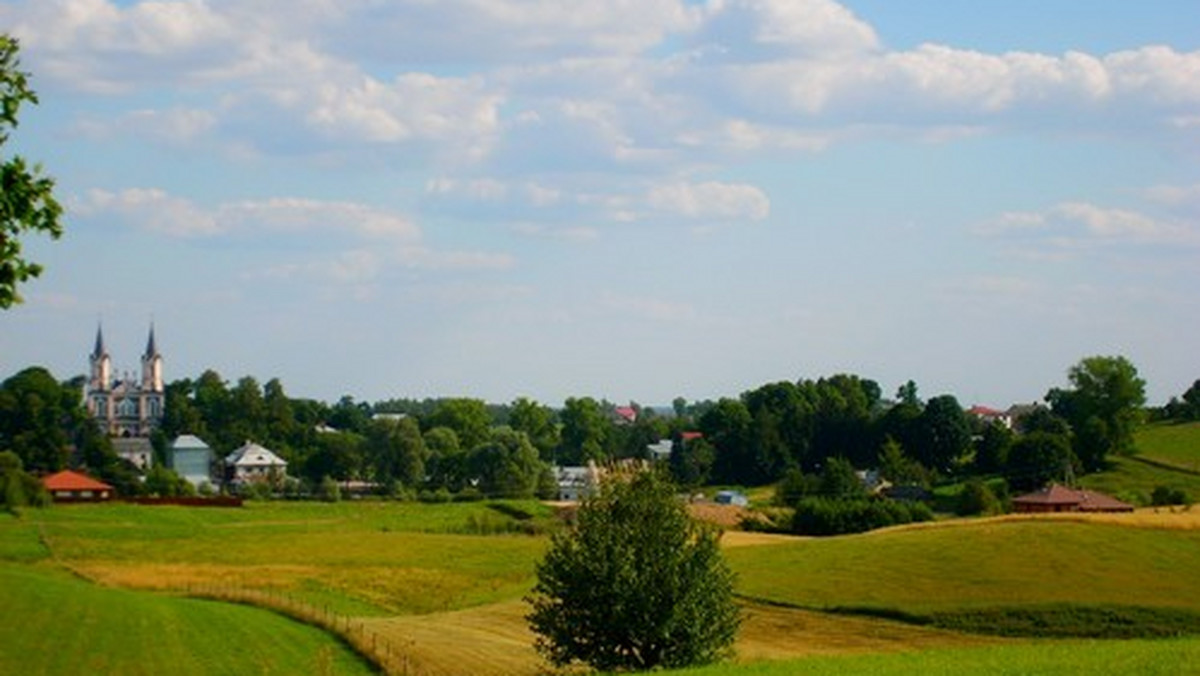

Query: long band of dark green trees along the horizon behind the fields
left=0, top=357, right=1185, bottom=497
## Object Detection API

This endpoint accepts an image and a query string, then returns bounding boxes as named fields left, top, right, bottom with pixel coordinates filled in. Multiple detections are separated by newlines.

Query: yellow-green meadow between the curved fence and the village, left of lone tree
left=36, top=503, right=548, bottom=615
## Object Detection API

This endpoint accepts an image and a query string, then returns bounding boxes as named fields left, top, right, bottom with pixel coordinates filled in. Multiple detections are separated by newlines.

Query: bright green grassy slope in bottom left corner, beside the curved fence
left=0, top=564, right=372, bottom=675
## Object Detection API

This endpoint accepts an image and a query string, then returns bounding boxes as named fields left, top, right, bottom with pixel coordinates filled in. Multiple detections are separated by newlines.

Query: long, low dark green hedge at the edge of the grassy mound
left=792, top=497, right=934, bottom=536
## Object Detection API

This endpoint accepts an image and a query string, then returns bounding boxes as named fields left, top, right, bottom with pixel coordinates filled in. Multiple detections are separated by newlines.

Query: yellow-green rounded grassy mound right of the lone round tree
left=727, top=520, right=1200, bottom=612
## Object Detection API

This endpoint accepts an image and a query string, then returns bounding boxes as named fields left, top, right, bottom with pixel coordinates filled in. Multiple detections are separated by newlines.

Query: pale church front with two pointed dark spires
left=84, top=325, right=166, bottom=438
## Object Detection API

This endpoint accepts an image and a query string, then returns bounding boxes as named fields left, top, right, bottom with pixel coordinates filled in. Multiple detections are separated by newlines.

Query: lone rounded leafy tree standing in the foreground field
left=527, top=471, right=739, bottom=671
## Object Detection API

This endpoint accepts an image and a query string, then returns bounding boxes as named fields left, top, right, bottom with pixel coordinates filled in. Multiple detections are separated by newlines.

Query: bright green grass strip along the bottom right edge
left=667, top=639, right=1200, bottom=676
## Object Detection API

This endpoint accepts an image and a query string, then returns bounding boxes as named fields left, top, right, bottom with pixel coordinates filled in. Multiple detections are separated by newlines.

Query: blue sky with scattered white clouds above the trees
left=0, top=0, right=1200, bottom=406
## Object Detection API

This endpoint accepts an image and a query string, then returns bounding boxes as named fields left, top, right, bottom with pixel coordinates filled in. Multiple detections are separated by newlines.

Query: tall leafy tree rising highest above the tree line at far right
left=1045, top=357, right=1146, bottom=471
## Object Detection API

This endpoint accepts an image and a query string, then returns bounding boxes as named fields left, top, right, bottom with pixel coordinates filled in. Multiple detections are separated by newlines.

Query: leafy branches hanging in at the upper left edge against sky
left=0, top=34, right=62, bottom=309
